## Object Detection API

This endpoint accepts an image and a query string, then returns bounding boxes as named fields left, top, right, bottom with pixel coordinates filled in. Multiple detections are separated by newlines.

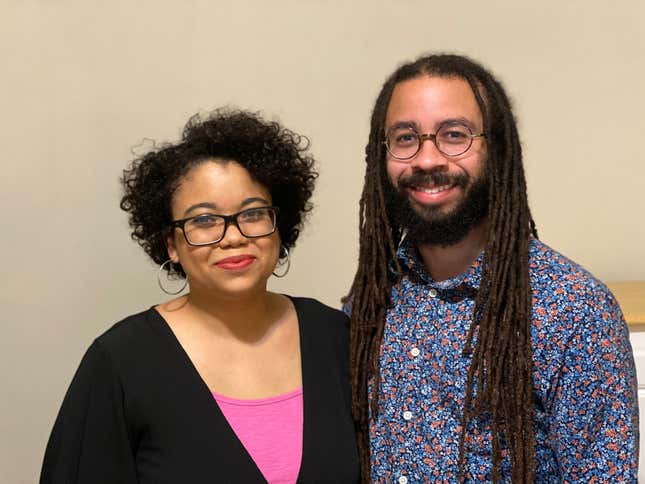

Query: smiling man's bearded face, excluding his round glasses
left=385, top=75, right=488, bottom=246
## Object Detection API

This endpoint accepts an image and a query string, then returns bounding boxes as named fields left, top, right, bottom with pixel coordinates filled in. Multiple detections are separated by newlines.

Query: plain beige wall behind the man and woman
left=0, top=0, right=645, bottom=484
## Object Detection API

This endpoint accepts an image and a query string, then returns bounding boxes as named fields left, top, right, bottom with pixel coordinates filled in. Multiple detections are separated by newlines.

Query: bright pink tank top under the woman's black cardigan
left=213, top=388, right=303, bottom=484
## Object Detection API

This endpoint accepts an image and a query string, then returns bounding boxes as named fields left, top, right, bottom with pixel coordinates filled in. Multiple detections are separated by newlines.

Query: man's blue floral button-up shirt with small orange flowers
left=360, top=240, right=638, bottom=484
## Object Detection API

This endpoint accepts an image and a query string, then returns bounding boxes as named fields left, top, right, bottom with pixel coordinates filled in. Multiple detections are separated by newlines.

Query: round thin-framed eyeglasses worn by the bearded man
left=384, top=122, right=485, bottom=161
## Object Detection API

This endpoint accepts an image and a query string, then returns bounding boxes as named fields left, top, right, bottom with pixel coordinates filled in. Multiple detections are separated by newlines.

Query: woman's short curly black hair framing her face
left=120, top=109, right=318, bottom=277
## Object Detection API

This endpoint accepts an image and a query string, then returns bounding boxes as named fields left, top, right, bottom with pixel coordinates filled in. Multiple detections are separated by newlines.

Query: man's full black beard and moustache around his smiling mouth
left=385, top=168, right=488, bottom=247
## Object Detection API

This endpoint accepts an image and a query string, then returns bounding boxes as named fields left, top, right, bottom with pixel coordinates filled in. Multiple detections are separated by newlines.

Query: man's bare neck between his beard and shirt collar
left=417, top=222, right=488, bottom=281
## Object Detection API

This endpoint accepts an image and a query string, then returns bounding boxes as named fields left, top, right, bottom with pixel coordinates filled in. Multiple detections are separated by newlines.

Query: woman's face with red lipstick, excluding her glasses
left=168, top=159, right=280, bottom=297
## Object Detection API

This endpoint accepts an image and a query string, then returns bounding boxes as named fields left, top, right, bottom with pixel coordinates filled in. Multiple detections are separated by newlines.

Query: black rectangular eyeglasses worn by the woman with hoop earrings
left=170, top=207, right=278, bottom=246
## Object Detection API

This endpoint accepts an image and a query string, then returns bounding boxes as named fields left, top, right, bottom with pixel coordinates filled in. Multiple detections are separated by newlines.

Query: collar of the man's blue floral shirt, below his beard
left=390, top=239, right=484, bottom=290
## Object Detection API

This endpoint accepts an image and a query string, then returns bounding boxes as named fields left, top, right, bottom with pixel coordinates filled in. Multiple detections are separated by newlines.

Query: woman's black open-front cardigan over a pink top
left=40, top=298, right=359, bottom=484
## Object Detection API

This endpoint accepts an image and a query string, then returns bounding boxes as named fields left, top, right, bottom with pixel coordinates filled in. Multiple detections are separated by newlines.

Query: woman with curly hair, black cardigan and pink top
left=41, top=111, right=358, bottom=484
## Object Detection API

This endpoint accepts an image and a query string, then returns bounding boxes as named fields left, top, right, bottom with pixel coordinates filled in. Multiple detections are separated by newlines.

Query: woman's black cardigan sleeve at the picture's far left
left=40, top=342, right=137, bottom=484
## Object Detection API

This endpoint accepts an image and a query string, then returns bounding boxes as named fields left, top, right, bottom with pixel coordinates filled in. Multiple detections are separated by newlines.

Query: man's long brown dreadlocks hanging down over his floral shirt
left=349, top=55, right=537, bottom=482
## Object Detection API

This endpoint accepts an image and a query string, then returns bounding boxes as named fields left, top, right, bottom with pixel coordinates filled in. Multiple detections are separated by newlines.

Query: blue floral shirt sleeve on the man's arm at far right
left=550, top=291, right=639, bottom=482
